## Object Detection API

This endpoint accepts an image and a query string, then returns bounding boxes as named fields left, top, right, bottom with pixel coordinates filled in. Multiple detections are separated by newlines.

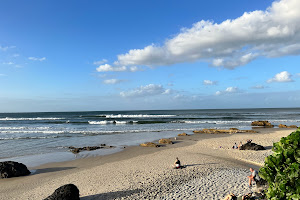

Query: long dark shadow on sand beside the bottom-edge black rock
left=80, top=189, right=142, bottom=200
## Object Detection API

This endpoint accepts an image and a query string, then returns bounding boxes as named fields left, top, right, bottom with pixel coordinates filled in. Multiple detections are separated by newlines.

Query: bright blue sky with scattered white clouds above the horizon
left=0, top=0, right=300, bottom=112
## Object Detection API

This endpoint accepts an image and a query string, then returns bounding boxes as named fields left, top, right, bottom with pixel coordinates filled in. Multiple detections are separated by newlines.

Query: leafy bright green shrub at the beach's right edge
left=259, top=128, right=300, bottom=200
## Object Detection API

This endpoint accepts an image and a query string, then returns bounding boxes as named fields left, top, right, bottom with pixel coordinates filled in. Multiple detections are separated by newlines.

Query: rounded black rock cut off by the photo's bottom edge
left=44, top=184, right=80, bottom=200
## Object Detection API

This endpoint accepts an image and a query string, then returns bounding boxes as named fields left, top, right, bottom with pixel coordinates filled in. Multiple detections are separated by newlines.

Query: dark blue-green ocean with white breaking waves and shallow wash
left=0, top=108, right=300, bottom=166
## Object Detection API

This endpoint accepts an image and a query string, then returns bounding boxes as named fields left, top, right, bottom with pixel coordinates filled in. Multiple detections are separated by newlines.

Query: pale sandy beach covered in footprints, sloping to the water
left=0, top=128, right=295, bottom=200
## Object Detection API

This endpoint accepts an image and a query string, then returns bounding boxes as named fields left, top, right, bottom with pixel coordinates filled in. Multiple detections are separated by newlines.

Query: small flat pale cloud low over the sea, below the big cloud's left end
left=120, top=84, right=171, bottom=97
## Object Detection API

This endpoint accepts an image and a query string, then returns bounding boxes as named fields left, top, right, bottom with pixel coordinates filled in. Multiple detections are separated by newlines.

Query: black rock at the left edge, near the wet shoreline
left=0, top=161, right=30, bottom=178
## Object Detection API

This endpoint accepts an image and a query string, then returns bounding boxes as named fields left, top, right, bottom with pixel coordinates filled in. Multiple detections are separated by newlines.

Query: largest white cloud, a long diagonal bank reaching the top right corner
left=109, top=0, right=300, bottom=69
